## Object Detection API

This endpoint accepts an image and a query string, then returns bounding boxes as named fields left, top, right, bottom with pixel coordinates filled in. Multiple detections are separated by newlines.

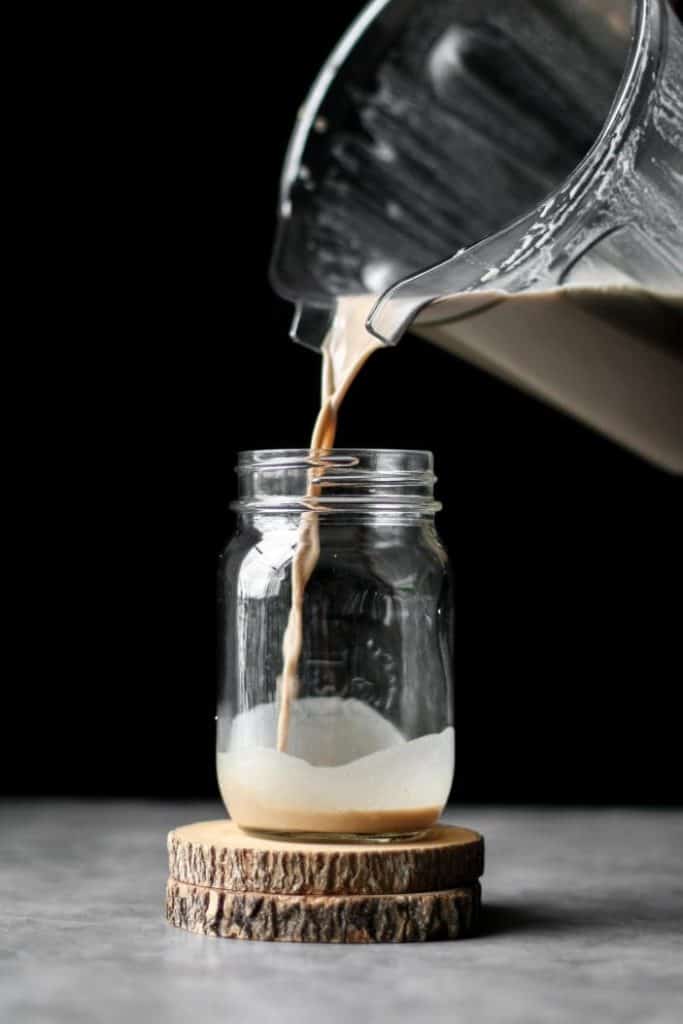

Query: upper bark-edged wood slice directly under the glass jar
left=168, top=819, right=483, bottom=896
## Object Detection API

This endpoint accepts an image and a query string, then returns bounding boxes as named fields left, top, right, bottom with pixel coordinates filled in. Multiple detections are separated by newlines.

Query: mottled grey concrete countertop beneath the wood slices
left=0, top=801, right=683, bottom=1024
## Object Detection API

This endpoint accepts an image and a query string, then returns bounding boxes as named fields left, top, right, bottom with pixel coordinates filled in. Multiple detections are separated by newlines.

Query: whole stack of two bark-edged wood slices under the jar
left=166, top=820, right=483, bottom=942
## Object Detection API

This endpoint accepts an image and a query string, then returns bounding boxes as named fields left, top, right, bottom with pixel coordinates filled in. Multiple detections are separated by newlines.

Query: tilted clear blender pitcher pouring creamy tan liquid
left=271, top=0, right=683, bottom=472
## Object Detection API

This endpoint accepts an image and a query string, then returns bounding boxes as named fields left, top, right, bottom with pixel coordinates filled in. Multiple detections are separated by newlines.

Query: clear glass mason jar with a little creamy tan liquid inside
left=217, top=449, right=455, bottom=841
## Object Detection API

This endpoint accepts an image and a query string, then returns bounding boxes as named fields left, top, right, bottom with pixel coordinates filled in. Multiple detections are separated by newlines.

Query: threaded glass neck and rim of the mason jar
left=232, top=449, right=441, bottom=516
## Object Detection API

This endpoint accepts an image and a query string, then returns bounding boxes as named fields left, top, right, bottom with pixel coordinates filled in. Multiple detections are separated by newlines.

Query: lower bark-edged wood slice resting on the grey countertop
left=166, top=879, right=481, bottom=943
